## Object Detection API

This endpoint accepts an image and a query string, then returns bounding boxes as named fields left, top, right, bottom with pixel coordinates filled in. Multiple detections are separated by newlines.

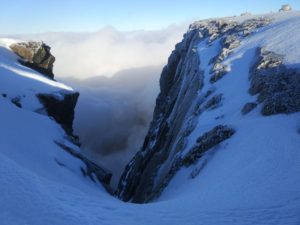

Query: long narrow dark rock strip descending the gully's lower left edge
left=55, top=142, right=112, bottom=194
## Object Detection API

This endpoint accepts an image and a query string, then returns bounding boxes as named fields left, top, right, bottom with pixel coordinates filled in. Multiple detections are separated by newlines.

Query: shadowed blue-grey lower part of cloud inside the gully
left=72, top=66, right=161, bottom=187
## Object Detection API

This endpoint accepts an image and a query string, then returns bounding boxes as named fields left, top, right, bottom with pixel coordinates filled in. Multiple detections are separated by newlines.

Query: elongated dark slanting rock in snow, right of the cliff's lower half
left=182, top=125, right=235, bottom=167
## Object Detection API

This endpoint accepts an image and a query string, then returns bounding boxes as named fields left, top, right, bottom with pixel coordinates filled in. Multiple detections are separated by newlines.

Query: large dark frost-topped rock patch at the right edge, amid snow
left=249, top=49, right=300, bottom=116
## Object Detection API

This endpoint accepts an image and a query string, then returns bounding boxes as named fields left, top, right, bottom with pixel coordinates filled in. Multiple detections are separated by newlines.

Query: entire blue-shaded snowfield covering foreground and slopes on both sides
left=0, top=12, right=300, bottom=225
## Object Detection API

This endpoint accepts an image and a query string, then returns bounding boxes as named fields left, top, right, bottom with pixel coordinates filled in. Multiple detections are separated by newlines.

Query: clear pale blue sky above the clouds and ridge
left=0, top=0, right=300, bottom=34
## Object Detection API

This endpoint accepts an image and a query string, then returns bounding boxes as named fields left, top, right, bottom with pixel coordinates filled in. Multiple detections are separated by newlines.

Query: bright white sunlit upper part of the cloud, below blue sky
left=18, top=24, right=187, bottom=79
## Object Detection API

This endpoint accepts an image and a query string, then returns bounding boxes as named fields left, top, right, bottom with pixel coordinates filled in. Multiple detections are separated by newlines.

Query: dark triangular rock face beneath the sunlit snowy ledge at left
left=37, top=92, right=79, bottom=135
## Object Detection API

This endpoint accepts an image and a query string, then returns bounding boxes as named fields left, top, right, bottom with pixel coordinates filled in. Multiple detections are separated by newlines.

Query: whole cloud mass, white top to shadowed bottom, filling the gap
left=15, top=24, right=187, bottom=187
